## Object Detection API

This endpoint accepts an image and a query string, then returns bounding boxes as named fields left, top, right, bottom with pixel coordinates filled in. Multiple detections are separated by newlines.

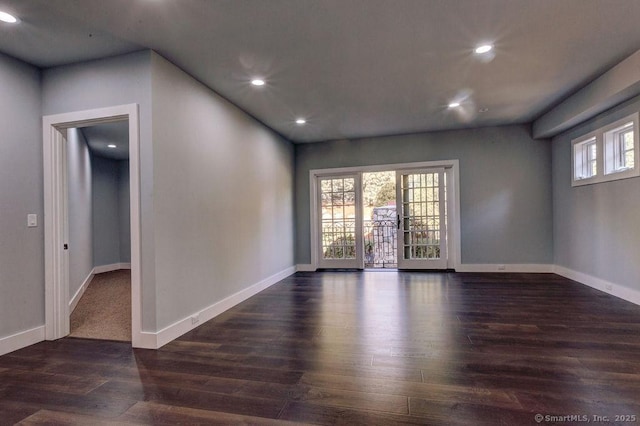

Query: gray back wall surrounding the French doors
left=296, top=126, right=553, bottom=264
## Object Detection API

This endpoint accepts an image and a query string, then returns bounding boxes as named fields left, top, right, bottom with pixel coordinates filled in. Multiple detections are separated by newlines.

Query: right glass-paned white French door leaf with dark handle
left=396, top=169, right=447, bottom=269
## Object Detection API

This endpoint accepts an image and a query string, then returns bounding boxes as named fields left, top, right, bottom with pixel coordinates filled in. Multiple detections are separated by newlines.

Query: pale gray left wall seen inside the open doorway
left=67, top=129, right=94, bottom=300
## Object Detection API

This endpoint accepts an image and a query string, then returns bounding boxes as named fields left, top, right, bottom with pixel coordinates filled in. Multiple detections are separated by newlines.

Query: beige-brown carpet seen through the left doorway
left=70, top=270, right=131, bottom=342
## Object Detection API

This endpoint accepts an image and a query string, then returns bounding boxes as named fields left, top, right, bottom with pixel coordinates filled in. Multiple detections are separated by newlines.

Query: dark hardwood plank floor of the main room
left=0, top=272, right=640, bottom=425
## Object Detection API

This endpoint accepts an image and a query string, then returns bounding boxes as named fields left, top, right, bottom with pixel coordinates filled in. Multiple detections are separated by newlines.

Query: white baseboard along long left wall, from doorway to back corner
left=141, top=266, right=296, bottom=349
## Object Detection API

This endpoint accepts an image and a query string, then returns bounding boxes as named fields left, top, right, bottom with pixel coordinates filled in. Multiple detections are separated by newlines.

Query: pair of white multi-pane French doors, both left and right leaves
left=316, top=168, right=448, bottom=269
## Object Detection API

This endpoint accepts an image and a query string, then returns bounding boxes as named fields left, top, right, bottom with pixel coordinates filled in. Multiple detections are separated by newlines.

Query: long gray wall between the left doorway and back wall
left=153, top=55, right=294, bottom=329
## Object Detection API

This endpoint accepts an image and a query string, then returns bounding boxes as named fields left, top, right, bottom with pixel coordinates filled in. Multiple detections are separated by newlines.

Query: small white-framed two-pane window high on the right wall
left=572, top=113, right=640, bottom=186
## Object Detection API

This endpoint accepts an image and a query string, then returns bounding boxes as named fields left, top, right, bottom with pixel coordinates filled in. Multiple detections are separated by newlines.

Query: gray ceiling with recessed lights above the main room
left=0, top=0, right=640, bottom=142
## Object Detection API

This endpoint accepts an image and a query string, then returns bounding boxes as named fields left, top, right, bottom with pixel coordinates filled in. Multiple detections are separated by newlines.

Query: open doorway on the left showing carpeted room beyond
left=66, top=120, right=131, bottom=342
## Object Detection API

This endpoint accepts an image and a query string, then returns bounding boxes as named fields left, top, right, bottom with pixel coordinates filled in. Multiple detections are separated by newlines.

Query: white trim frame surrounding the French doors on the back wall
left=309, top=160, right=462, bottom=270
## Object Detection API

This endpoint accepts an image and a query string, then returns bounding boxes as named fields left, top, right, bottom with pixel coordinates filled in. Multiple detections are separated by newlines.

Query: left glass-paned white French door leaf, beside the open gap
left=317, top=173, right=363, bottom=269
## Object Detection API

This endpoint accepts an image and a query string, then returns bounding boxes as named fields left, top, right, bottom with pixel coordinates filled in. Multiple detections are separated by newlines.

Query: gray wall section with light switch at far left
left=0, top=54, right=44, bottom=338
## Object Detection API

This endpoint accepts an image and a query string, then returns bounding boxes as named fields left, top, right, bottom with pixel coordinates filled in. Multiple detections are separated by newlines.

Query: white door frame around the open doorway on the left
left=42, top=104, right=142, bottom=347
